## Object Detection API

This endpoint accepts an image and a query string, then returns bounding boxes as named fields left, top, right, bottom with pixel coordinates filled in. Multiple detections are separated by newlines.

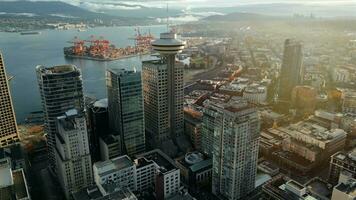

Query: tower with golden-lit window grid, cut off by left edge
left=0, top=53, right=19, bottom=147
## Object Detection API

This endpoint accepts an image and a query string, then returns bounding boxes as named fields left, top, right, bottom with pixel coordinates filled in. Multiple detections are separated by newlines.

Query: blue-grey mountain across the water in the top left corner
left=0, top=1, right=108, bottom=18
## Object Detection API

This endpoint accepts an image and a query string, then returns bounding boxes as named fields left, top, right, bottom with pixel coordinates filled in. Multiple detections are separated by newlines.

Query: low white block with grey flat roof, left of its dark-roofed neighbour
left=93, top=155, right=137, bottom=194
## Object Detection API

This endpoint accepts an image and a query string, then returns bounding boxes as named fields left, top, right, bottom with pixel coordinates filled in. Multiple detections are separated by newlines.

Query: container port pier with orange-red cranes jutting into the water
left=64, top=36, right=153, bottom=61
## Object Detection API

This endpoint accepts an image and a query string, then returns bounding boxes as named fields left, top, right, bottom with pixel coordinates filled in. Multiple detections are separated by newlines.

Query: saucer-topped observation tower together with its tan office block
left=143, top=33, right=185, bottom=142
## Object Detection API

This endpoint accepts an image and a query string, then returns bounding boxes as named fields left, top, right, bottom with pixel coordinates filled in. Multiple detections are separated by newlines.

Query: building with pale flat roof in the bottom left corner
left=0, top=158, right=31, bottom=200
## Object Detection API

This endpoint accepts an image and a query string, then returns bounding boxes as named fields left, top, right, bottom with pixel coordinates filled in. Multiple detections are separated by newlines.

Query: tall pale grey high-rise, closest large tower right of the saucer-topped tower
left=207, top=99, right=260, bottom=200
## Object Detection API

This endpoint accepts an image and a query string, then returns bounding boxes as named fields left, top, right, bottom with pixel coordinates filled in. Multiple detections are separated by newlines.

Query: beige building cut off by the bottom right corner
left=331, top=172, right=356, bottom=200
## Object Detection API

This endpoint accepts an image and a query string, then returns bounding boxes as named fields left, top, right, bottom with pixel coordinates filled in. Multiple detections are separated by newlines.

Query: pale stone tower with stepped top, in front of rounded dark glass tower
left=56, top=109, right=93, bottom=199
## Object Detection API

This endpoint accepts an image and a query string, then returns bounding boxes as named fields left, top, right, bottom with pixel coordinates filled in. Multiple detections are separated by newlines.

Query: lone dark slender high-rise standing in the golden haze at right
left=278, top=39, right=303, bottom=104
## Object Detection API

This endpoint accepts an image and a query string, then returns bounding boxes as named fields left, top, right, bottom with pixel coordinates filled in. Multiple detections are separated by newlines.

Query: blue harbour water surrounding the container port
left=0, top=26, right=166, bottom=123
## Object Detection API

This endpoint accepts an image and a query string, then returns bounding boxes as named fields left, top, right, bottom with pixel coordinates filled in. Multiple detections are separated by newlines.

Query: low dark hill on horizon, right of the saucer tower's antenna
left=204, top=12, right=278, bottom=21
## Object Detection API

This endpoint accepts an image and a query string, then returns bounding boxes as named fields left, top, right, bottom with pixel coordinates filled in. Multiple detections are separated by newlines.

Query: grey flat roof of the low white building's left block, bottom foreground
left=94, top=155, right=134, bottom=176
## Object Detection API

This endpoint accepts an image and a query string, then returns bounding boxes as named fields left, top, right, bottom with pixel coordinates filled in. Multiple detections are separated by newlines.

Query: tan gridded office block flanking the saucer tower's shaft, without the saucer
left=142, top=60, right=184, bottom=142
